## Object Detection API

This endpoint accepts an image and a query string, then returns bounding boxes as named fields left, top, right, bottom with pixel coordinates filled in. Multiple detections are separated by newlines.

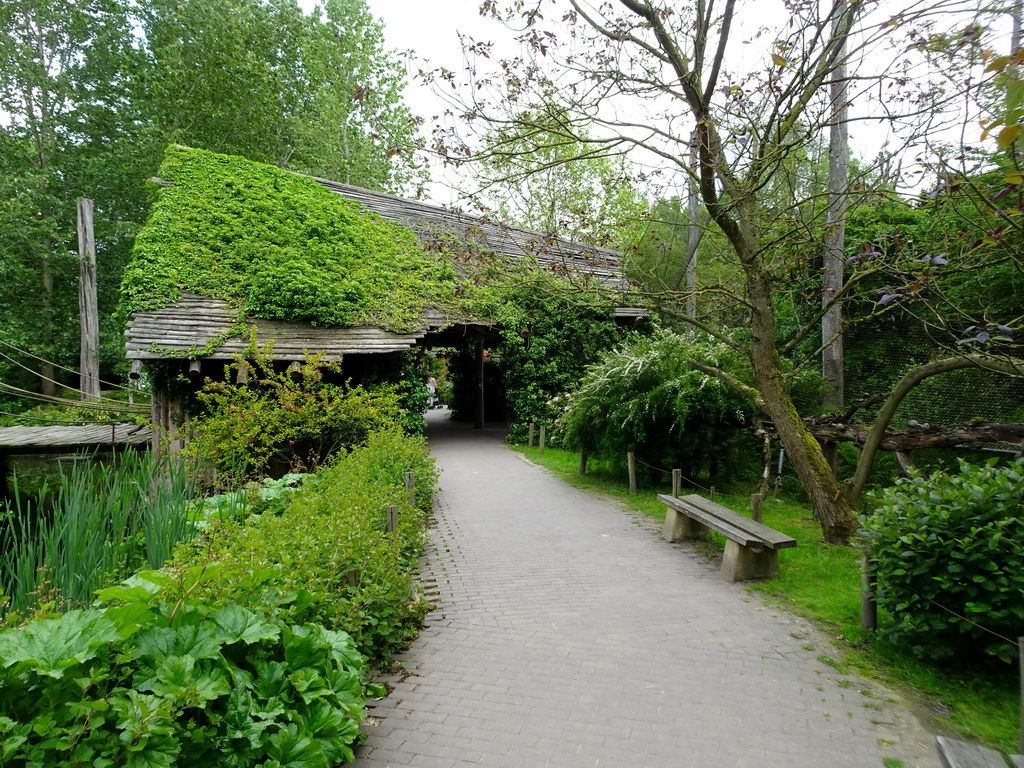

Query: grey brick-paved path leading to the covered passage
left=356, top=417, right=938, bottom=768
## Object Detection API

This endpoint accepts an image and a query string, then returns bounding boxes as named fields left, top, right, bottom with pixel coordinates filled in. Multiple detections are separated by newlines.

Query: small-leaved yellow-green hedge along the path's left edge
left=175, top=428, right=437, bottom=662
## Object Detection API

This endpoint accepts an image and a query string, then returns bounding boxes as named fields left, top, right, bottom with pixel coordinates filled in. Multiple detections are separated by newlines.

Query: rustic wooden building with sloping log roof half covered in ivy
left=122, top=146, right=644, bottom=444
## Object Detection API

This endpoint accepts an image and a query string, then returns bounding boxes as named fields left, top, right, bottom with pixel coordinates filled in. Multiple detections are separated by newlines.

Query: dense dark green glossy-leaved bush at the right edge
left=862, top=459, right=1024, bottom=660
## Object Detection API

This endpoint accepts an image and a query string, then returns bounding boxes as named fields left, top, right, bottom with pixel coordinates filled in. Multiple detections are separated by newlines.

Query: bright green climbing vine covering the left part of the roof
left=121, top=145, right=456, bottom=331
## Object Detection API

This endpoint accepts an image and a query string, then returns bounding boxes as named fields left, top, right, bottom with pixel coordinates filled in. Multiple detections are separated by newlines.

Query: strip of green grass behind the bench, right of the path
left=515, top=445, right=1020, bottom=754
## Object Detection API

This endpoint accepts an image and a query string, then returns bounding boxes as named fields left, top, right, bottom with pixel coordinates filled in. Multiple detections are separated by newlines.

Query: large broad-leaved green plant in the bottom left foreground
left=0, top=568, right=382, bottom=768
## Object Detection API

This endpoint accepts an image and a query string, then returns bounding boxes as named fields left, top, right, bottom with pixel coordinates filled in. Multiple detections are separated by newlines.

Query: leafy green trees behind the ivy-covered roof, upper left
left=0, top=0, right=421, bottom=397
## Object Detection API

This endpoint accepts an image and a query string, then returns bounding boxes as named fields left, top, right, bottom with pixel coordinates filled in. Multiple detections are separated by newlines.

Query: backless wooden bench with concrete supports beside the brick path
left=657, top=494, right=797, bottom=582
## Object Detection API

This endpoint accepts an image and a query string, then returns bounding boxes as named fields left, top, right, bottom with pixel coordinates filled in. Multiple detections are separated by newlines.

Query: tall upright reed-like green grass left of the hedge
left=0, top=452, right=194, bottom=611
